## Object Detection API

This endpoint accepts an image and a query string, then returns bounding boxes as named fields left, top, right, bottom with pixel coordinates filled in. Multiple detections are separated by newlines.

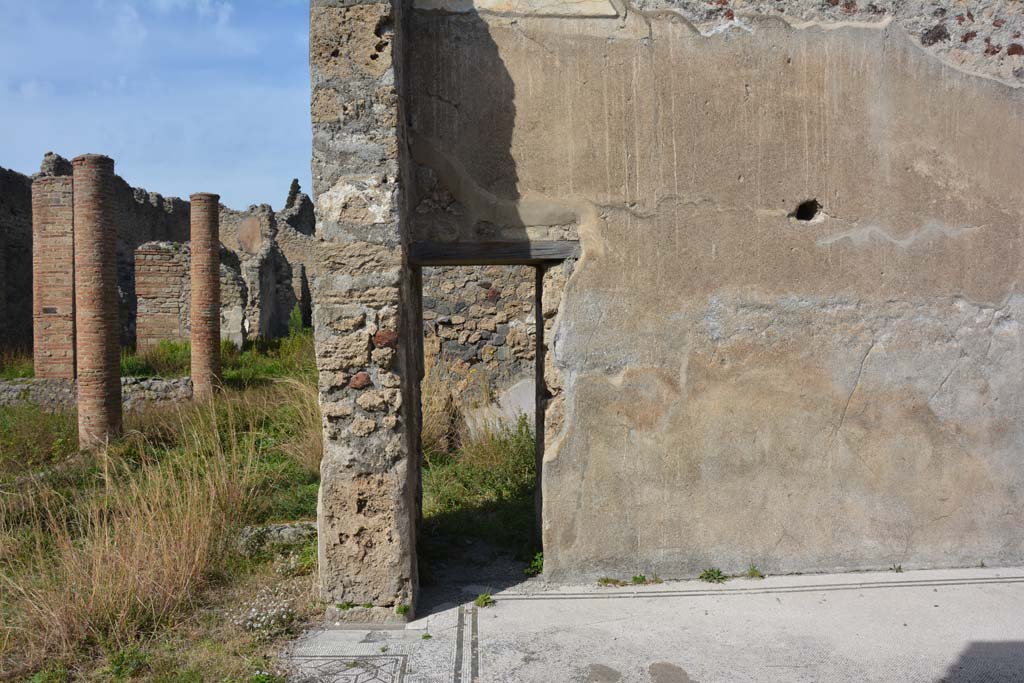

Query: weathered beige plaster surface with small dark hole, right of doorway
left=404, top=3, right=1024, bottom=580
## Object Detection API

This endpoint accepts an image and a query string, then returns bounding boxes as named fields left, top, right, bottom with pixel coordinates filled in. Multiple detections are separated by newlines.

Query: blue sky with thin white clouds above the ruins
left=0, top=0, right=311, bottom=209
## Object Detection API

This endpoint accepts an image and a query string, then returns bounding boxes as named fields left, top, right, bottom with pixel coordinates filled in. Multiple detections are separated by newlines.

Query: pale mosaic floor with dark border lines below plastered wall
left=284, top=568, right=1024, bottom=683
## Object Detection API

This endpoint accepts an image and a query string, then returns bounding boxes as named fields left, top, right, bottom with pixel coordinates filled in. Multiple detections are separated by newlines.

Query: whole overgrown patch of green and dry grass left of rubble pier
left=0, top=380, right=321, bottom=680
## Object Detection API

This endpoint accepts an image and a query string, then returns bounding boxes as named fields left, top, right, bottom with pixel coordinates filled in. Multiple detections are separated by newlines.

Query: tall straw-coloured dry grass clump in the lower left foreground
left=0, top=401, right=255, bottom=667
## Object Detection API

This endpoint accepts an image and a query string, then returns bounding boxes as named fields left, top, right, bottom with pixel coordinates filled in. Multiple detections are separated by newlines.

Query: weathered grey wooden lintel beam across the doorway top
left=409, top=240, right=580, bottom=266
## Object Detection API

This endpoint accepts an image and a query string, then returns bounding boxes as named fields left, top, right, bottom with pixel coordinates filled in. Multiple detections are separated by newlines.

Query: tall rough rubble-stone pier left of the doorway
left=309, top=0, right=423, bottom=622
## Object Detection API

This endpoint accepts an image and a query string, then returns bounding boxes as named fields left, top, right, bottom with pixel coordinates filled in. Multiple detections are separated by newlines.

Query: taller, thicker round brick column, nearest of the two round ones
left=72, top=155, right=121, bottom=449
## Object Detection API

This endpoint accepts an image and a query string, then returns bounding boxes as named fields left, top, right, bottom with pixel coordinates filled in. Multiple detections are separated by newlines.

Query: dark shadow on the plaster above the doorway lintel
left=407, top=11, right=528, bottom=242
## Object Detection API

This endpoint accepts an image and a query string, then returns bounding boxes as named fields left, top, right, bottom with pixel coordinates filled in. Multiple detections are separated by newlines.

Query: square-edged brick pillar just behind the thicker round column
left=32, top=175, right=75, bottom=380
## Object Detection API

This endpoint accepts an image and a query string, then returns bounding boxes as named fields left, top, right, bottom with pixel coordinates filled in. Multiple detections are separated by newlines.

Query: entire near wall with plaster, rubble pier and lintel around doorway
left=310, top=0, right=1024, bottom=618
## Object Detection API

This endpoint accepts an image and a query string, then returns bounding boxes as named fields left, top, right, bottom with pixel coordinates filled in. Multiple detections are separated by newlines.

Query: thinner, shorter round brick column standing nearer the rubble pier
left=191, top=193, right=220, bottom=398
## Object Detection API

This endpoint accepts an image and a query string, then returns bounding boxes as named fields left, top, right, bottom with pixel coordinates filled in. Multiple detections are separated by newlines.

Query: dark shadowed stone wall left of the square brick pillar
left=0, top=168, right=32, bottom=351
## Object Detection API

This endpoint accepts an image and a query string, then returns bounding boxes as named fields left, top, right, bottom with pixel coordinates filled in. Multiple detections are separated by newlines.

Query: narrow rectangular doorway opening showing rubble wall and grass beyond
left=418, top=265, right=544, bottom=609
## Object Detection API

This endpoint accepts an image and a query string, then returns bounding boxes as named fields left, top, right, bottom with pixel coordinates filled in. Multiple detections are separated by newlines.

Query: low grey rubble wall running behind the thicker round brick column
left=0, top=377, right=191, bottom=411
